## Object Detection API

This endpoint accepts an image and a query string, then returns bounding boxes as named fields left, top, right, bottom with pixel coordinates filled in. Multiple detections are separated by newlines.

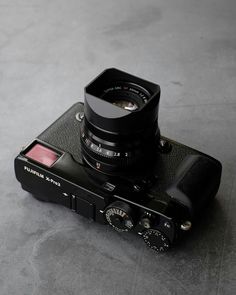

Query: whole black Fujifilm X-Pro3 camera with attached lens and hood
left=15, top=68, right=222, bottom=251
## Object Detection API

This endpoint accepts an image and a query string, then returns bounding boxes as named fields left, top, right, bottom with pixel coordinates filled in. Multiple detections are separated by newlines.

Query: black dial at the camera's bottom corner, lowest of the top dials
left=143, top=228, right=170, bottom=252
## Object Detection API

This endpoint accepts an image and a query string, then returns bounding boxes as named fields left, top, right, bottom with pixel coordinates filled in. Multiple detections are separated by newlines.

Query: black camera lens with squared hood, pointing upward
left=81, top=69, right=160, bottom=174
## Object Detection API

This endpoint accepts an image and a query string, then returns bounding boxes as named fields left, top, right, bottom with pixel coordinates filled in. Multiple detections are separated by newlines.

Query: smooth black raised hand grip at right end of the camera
left=166, top=155, right=222, bottom=218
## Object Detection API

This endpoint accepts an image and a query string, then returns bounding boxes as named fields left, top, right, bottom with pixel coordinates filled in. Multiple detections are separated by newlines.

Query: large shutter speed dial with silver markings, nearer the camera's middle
left=104, top=201, right=134, bottom=232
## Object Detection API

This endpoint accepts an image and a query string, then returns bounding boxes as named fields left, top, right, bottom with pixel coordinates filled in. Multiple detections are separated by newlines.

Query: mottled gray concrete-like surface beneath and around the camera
left=0, top=0, right=236, bottom=295
